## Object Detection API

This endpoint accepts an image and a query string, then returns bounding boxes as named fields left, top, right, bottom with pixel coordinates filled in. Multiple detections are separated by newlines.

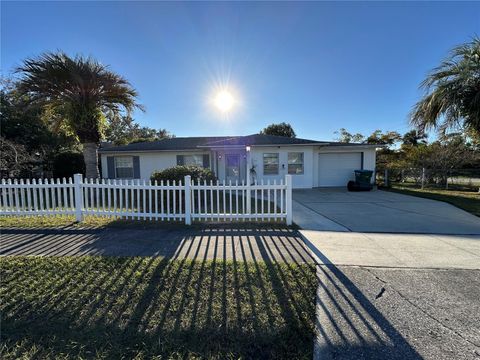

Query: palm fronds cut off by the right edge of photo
left=410, top=37, right=480, bottom=133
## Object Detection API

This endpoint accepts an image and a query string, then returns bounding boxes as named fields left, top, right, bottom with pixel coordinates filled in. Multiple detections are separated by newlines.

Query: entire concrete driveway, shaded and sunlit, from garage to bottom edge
left=293, top=189, right=480, bottom=360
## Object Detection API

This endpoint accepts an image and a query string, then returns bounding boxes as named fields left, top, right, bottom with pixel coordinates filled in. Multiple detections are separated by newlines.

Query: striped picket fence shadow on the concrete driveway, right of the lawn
left=304, top=238, right=422, bottom=359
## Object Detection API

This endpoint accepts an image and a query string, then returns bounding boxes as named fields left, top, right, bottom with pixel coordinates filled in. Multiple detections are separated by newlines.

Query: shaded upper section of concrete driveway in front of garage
left=293, top=188, right=480, bottom=235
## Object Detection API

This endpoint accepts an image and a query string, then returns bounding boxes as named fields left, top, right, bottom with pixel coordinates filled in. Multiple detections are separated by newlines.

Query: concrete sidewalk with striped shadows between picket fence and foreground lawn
left=0, top=227, right=313, bottom=263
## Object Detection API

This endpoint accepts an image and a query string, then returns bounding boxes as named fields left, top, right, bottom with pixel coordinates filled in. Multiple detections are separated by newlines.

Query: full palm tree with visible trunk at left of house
left=17, top=52, right=141, bottom=178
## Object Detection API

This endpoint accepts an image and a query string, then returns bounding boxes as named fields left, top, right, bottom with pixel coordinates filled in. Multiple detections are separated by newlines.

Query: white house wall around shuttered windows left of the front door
left=101, top=151, right=212, bottom=180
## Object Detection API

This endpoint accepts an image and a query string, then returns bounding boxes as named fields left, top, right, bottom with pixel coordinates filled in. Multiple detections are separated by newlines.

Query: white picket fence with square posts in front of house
left=0, top=174, right=292, bottom=225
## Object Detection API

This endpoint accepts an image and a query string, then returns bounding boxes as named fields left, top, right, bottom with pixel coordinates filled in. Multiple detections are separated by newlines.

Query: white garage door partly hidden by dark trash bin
left=318, top=152, right=362, bottom=186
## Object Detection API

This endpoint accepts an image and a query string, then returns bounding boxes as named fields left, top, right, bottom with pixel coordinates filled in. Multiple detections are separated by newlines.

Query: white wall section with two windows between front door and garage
left=247, top=146, right=313, bottom=188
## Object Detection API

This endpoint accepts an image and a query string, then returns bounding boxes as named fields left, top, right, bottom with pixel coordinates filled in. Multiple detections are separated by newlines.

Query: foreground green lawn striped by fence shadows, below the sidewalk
left=0, top=257, right=316, bottom=359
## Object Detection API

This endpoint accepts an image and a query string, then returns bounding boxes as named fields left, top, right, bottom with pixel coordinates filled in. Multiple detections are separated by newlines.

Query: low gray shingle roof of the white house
left=96, top=134, right=363, bottom=152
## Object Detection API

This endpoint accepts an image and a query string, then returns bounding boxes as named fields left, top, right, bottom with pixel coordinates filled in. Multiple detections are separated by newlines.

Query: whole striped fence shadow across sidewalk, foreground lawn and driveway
left=0, top=226, right=419, bottom=359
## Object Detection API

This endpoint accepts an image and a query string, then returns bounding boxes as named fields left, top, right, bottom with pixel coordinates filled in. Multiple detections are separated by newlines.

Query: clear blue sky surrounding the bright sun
left=1, top=1, right=480, bottom=140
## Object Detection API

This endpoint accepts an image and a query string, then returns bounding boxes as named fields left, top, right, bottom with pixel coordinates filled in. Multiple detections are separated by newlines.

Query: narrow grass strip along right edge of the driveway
left=385, top=184, right=480, bottom=216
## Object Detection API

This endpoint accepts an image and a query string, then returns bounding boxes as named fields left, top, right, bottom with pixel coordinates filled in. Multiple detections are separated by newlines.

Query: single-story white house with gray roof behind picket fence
left=99, top=134, right=376, bottom=188
